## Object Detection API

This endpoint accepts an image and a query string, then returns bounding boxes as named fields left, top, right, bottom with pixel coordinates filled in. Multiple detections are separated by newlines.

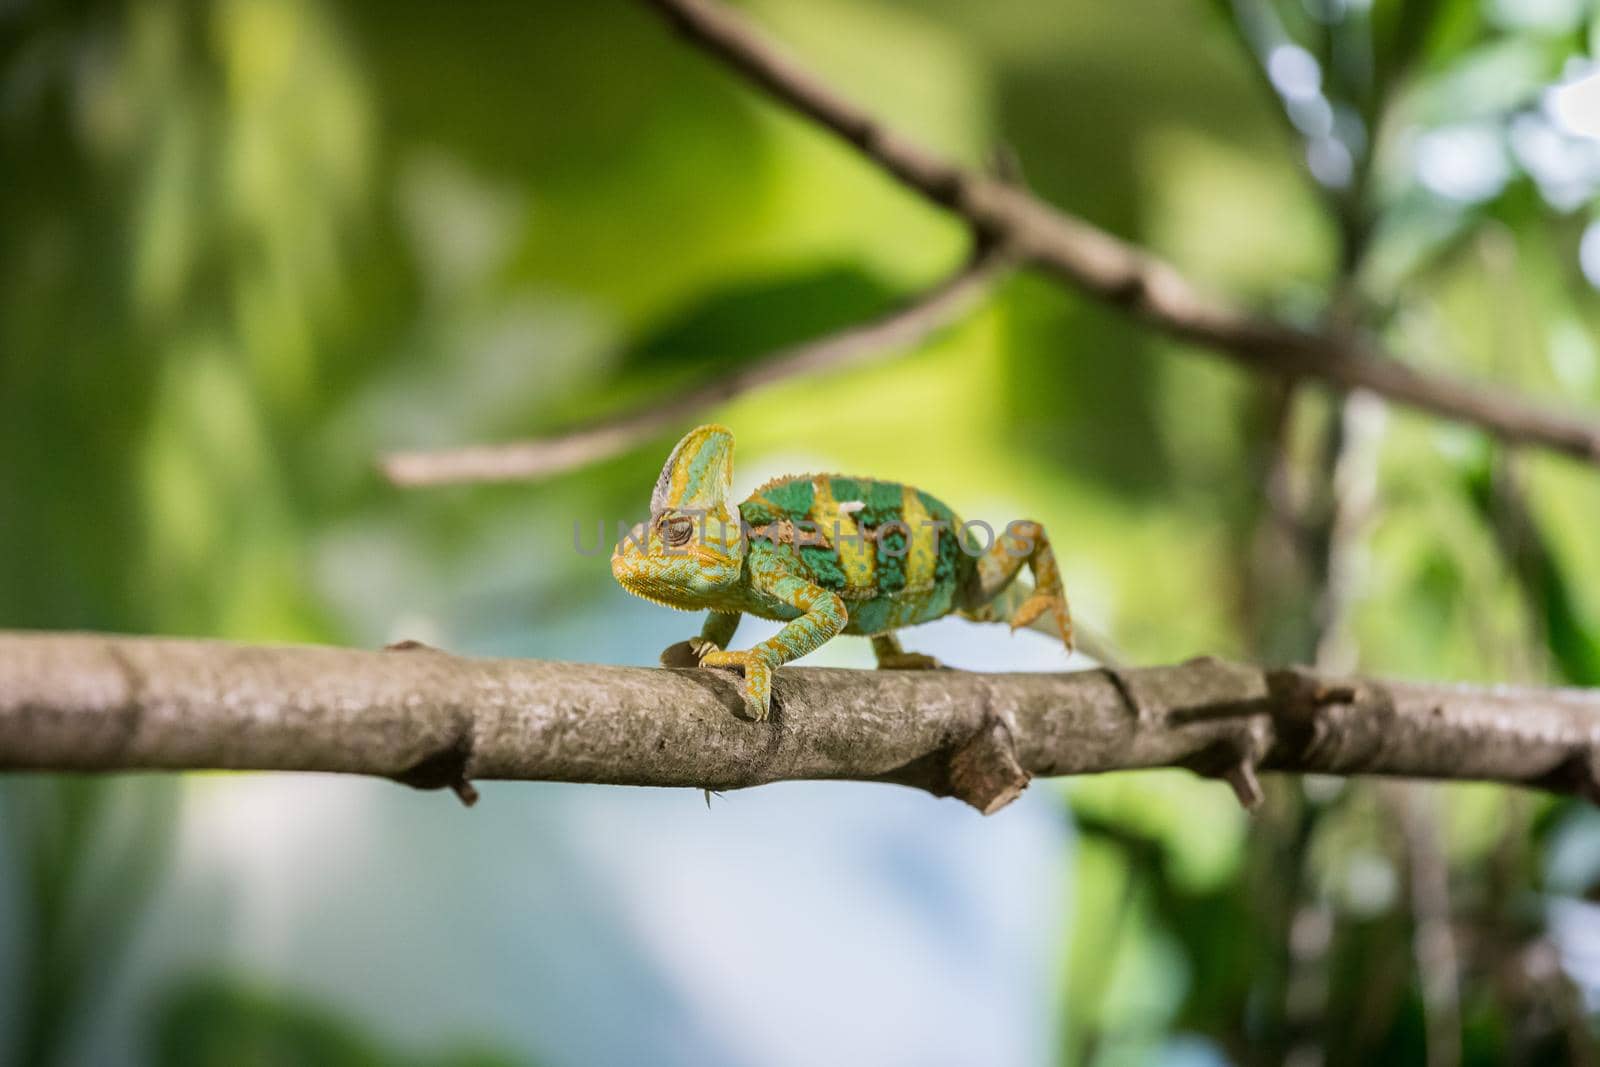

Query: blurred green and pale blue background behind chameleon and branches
left=9, top=0, right=1600, bottom=1065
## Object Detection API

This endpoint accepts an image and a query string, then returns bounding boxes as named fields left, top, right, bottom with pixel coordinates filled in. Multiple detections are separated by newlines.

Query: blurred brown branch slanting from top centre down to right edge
left=646, top=0, right=1600, bottom=462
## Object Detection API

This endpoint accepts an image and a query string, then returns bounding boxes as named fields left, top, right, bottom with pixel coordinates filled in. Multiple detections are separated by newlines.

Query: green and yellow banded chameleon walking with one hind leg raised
left=611, top=426, right=1072, bottom=721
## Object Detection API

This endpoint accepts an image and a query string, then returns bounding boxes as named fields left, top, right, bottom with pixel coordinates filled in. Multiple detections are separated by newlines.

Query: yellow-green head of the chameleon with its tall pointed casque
left=611, top=426, right=746, bottom=609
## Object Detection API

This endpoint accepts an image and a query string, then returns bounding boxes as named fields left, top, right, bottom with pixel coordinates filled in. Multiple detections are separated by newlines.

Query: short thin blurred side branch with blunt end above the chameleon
left=379, top=242, right=1014, bottom=486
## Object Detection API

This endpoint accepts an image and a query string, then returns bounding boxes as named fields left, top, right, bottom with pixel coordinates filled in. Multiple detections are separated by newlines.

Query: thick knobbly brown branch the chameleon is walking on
left=0, top=633, right=1600, bottom=813
